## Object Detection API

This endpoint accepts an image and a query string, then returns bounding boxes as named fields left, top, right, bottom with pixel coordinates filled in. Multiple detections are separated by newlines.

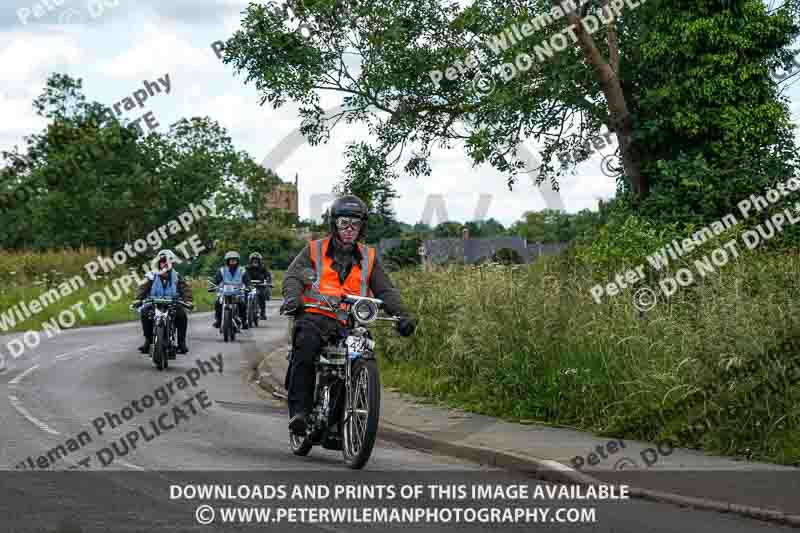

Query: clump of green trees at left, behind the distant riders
left=0, top=74, right=277, bottom=256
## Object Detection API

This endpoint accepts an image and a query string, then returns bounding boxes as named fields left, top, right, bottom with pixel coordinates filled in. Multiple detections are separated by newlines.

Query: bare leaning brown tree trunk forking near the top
left=553, top=0, right=649, bottom=205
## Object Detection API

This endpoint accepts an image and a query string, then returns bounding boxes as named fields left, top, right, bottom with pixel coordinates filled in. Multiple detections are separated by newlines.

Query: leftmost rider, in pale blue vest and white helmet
left=136, top=250, right=192, bottom=354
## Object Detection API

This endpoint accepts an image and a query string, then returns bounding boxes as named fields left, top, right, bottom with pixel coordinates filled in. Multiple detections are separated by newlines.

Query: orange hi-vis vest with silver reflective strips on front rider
left=303, top=237, right=375, bottom=318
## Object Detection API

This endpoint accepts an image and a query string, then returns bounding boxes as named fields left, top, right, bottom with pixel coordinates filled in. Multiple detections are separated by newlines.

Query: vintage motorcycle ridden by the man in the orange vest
left=285, top=271, right=399, bottom=469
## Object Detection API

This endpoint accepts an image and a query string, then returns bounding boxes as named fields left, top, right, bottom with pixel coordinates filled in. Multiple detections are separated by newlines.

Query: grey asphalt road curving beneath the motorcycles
left=0, top=302, right=789, bottom=533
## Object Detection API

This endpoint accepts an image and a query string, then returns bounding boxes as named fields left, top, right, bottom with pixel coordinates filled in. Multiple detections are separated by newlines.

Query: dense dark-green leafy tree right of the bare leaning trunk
left=621, top=0, right=798, bottom=220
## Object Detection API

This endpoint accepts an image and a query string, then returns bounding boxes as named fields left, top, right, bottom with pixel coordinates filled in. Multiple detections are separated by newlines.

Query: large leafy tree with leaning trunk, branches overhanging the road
left=224, top=0, right=798, bottom=216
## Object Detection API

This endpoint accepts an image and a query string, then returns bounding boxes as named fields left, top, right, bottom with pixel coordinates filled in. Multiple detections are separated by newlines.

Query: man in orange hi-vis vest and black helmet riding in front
left=280, top=196, right=416, bottom=435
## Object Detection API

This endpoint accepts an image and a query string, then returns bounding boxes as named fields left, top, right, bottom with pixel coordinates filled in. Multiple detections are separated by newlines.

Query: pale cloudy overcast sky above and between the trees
left=0, top=0, right=800, bottom=225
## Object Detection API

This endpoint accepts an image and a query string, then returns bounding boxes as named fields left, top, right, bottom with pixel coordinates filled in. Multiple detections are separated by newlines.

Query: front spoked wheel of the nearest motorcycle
left=342, top=359, right=381, bottom=469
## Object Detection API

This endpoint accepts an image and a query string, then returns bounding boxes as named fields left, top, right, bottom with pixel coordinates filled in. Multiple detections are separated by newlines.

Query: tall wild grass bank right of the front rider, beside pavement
left=373, top=253, right=800, bottom=465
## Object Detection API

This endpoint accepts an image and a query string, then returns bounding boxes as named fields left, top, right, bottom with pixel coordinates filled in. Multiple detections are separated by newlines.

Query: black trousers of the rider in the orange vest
left=286, top=313, right=341, bottom=417
